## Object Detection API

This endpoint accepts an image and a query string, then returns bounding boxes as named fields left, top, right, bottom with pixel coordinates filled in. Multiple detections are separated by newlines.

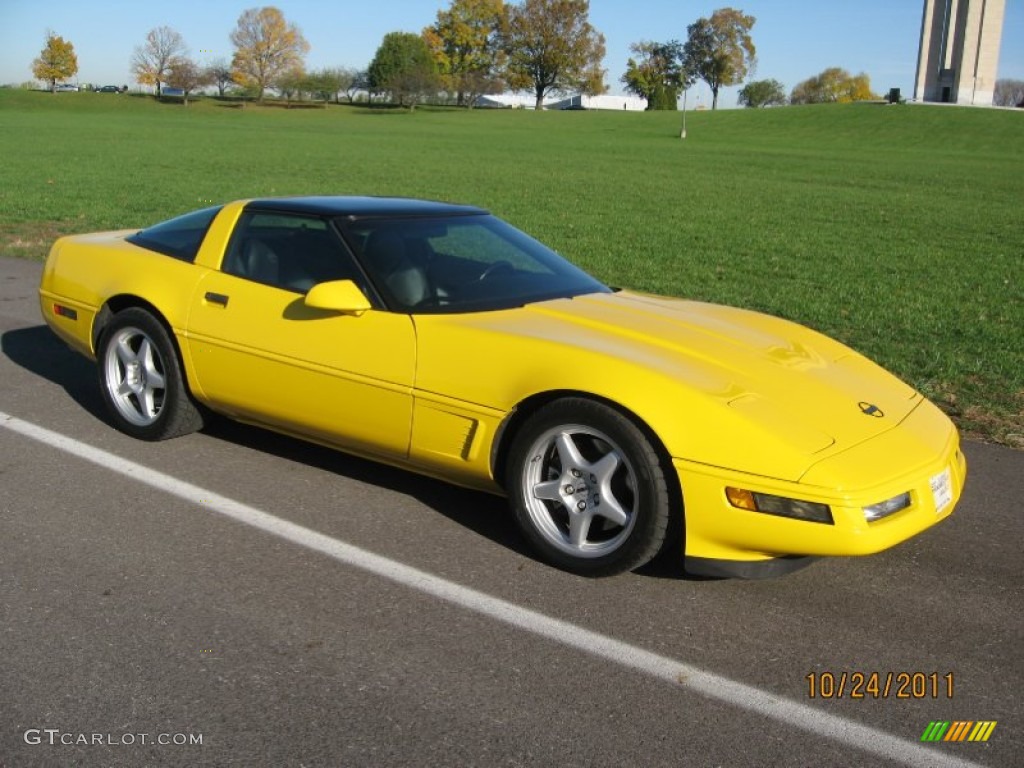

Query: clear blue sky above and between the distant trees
left=0, top=0, right=1024, bottom=106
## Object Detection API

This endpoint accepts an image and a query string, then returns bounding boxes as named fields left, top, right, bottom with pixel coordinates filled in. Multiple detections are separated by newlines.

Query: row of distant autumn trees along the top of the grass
left=39, top=0, right=1007, bottom=110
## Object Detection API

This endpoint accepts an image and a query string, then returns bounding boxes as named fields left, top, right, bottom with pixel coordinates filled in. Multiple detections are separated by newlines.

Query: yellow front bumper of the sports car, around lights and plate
left=673, top=400, right=967, bottom=575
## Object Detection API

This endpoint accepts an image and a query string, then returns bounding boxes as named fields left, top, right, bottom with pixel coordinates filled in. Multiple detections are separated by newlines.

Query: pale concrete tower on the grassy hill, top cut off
left=913, top=0, right=1006, bottom=105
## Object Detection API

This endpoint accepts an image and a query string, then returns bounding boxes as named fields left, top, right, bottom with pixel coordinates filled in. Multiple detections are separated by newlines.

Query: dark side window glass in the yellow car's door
left=221, top=211, right=366, bottom=293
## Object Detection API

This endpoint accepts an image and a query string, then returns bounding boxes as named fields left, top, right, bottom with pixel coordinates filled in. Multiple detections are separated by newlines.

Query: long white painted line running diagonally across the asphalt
left=0, top=411, right=981, bottom=768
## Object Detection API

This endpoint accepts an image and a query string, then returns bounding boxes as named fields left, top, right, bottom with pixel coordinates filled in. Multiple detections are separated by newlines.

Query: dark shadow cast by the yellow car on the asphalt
left=0, top=326, right=693, bottom=579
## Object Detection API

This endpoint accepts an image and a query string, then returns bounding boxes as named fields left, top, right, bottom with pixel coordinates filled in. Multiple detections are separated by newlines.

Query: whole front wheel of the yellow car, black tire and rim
left=505, top=397, right=671, bottom=577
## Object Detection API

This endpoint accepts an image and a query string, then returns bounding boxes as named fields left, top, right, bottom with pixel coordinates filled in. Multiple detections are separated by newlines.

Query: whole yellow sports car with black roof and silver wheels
left=39, top=197, right=967, bottom=578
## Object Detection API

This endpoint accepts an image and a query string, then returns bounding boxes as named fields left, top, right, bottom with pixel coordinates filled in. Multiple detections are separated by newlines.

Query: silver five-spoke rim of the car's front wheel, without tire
left=520, top=424, right=638, bottom=559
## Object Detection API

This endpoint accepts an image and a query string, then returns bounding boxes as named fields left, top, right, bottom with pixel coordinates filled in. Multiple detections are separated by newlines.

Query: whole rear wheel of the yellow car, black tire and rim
left=96, top=307, right=203, bottom=440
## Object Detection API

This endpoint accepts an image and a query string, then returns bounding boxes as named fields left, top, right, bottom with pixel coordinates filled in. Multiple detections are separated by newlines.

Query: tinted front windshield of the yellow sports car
left=338, top=214, right=610, bottom=313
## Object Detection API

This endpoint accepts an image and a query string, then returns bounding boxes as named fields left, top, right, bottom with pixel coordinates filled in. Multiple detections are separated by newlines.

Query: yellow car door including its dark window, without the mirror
left=186, top=212, right=416, bottom=457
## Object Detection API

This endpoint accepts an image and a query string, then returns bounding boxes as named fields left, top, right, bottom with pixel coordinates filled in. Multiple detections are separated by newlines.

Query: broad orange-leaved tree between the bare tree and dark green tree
left=231, top=6, right=309, bottom=101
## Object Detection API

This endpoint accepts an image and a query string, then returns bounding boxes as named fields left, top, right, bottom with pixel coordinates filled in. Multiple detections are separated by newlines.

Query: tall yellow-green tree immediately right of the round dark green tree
left=423, top=0, right=505, bottom=106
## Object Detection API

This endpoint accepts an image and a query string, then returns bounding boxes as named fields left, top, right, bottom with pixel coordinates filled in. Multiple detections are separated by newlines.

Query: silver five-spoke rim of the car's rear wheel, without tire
left=103, top=326, right=167, bottom=427
